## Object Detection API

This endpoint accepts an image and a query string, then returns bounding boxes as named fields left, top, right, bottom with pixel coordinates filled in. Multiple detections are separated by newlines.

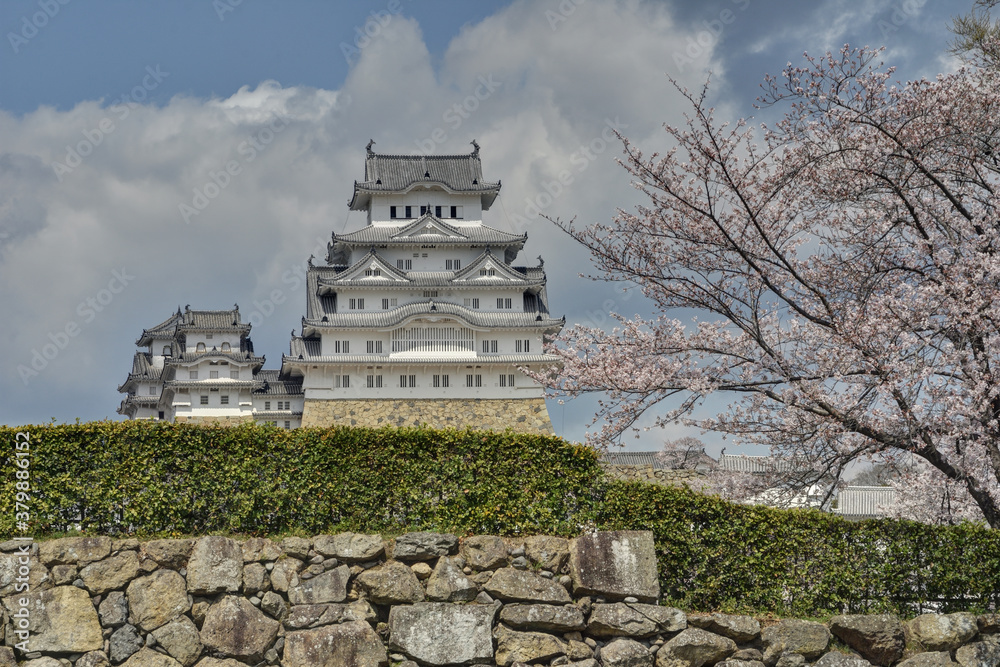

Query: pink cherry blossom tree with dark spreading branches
left=539, top=47, right=1000, bottom=527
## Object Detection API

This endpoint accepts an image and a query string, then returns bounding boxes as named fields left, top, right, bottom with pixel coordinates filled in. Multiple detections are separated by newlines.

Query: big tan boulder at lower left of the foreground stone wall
left=4, top=586, right=104, bottom=653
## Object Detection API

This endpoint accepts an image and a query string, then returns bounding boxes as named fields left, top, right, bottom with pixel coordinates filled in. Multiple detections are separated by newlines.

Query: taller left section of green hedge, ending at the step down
left=0, top=421, right=600, bottom=536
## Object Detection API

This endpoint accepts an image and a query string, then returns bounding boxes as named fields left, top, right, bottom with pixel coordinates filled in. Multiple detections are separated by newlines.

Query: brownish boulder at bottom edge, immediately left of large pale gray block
left=281, top=621, right=389, bottom=667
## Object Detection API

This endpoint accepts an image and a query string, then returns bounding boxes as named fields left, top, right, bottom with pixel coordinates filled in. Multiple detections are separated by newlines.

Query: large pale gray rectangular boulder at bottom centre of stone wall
left=389, top=602, right=497, bottom=665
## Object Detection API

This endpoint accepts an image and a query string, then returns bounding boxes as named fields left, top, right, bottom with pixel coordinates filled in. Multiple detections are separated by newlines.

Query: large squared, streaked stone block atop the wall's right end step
left=569, top=530, right=660, bottom=602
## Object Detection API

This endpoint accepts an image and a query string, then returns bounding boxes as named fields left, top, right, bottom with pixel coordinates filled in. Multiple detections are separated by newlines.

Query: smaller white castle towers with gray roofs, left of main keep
left=118, top=306, right=302, bottom=428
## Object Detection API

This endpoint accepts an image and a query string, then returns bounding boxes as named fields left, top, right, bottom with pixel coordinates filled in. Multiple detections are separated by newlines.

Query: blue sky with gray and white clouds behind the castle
left=0, top=0, right=971, bottom=451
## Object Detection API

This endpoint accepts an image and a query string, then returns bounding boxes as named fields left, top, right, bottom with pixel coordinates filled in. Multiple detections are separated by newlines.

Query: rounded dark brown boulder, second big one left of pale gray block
left=201, top=595, right=280, bottom=662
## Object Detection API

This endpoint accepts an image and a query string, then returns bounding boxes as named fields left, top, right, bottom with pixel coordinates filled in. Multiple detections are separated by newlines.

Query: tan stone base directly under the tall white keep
left=302, top=398, right=555, bottom=435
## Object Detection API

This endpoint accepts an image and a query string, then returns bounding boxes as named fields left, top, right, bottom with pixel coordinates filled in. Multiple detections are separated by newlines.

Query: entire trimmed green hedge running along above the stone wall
left=0, top=421, right=1000, bottom=616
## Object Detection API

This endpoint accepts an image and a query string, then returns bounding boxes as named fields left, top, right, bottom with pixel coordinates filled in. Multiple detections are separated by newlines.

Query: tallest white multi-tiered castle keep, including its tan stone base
left=281, top=142, right=564, bottom=433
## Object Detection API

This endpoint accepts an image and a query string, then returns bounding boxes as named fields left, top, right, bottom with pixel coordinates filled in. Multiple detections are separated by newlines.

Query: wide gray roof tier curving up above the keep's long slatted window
left=302, top=299, right=566, bottom=331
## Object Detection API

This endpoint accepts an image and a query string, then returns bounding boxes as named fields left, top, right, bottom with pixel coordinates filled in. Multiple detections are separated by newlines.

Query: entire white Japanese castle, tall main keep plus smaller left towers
left=119, top=142, right=565, bottom=433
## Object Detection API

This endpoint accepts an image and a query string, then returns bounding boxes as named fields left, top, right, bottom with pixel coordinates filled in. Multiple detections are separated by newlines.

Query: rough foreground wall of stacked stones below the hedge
left=0, top=531, right=1000, bottom=667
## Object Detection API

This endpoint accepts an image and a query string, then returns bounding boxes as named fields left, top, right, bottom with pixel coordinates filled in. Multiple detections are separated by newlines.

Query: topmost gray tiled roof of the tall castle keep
left=350, top=142, right=500, bottom=211
